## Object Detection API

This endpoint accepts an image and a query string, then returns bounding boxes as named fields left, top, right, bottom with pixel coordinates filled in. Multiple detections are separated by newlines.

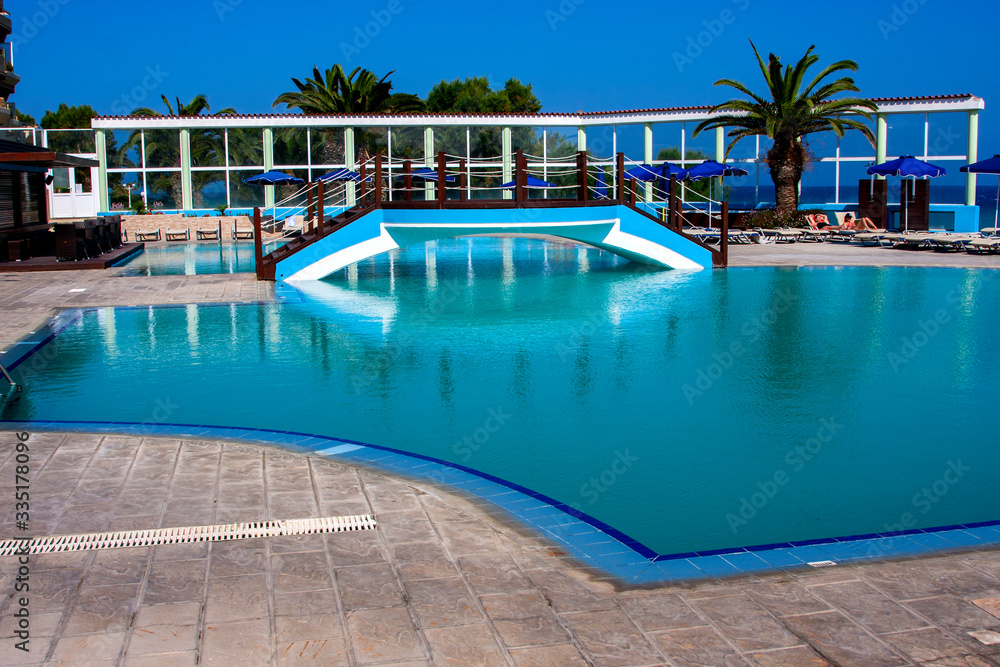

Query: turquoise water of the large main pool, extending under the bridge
left=7, top=238, right=1000, bottom=554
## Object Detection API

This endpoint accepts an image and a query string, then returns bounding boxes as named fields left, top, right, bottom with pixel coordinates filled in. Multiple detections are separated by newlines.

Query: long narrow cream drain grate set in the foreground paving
left=0, top=514, right=378, bottom=556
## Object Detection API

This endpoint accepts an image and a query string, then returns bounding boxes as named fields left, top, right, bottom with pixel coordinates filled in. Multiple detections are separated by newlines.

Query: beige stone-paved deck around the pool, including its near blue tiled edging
left=0, top=254, right=1000, bottom=665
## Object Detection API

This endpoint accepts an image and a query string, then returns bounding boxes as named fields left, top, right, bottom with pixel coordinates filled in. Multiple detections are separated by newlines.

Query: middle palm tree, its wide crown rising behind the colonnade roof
left=271, top=65, right=425, bottom=164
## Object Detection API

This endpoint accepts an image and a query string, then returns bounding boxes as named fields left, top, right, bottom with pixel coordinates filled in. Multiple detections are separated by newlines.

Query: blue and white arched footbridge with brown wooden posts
left=254, top=153, right=728, bottom=281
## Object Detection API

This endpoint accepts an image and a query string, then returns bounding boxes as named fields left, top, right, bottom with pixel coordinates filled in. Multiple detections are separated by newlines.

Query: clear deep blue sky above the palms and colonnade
left=5, top=0, right=1000, bottom=151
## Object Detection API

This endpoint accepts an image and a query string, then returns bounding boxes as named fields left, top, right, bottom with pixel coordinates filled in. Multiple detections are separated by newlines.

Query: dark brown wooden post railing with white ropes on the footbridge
left=254, top=151, right=729, bottom=279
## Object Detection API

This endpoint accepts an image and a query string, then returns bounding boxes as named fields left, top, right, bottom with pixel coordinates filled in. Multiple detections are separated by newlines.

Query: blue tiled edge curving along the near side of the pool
left=0, top=420, right=1000, bottom=584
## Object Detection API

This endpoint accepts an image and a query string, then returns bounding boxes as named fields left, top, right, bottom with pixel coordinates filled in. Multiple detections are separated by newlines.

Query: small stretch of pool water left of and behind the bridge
left=122, top=241, right=288, bottom=276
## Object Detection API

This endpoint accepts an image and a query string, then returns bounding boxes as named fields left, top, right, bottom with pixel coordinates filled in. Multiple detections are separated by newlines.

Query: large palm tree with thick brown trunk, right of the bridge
left=694, top=41, right=877, bottom=212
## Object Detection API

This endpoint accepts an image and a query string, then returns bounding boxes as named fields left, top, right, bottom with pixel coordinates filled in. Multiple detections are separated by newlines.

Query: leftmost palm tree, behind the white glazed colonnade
left=118, top=95, right=236, bottom=208
